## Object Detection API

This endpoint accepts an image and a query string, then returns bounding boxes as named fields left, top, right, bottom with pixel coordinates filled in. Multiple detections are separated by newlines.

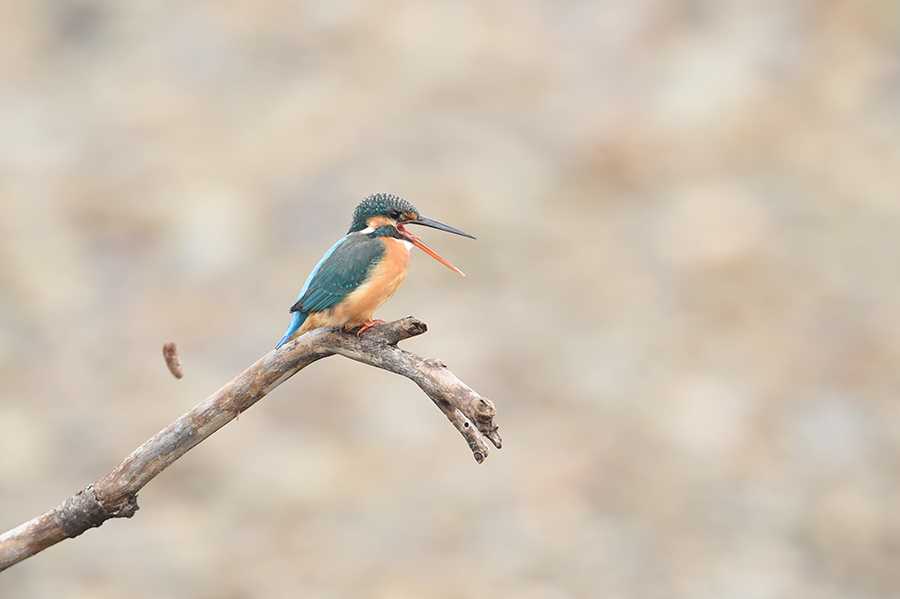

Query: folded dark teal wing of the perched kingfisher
left=291, top=235, right=384, bottom=314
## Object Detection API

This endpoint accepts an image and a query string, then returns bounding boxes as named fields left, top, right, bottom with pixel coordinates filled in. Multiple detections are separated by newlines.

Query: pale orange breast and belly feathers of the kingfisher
left=300, top=237, right=409, bottom=332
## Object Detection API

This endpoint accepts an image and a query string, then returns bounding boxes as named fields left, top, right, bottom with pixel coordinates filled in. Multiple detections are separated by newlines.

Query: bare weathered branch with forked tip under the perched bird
left=0, top=316, right=502, bottom=570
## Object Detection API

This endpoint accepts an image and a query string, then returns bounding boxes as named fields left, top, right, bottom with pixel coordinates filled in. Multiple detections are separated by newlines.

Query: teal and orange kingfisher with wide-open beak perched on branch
left=275, top=193, right=475, bottom=349
